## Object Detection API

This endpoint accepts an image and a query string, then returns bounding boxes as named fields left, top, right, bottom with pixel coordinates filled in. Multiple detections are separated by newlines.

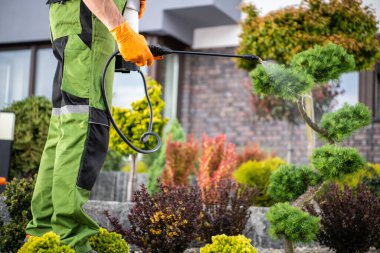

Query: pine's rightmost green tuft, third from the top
left=320, top=103, right=371, bottom=142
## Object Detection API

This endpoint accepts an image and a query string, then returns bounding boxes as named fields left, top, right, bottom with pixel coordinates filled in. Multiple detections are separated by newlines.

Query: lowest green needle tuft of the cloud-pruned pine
left=266, top=203, right=320, bottom=242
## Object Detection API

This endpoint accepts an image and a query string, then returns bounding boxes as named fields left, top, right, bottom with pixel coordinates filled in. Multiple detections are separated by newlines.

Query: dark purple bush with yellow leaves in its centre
left=109, top=185, right=202, bottom=253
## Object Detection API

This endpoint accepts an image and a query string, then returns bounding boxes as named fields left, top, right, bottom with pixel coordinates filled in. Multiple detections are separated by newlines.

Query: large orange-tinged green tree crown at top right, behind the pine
left=238, top=0, right=380, bottom=71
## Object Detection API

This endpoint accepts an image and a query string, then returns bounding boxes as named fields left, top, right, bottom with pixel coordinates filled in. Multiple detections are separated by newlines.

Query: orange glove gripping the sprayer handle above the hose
left=110, top=22, right=154, bottom=66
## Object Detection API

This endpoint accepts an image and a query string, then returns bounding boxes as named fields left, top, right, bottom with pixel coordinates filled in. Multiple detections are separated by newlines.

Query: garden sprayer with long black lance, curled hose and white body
left=101, top=0, right=262, bottom=154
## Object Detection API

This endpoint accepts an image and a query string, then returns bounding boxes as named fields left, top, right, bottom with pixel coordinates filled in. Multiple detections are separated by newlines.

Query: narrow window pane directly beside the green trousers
left=34, top=48, right=57, bottom=100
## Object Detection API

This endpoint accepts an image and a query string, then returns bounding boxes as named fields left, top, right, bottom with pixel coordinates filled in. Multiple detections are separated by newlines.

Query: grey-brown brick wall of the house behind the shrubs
left=180, top=48, right=380, bottom=163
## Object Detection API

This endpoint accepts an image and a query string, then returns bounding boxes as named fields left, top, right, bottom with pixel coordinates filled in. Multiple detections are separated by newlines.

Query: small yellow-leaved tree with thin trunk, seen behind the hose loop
left=109, top=79, right=168, bottom=201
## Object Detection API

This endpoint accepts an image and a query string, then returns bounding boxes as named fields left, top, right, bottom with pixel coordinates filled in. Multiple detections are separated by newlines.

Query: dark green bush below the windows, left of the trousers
left=3, top=97, right=52, bottom=178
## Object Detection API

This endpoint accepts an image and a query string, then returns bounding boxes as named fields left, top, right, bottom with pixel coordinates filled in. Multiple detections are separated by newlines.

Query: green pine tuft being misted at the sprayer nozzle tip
left=249, top=63, right=314, bottom=101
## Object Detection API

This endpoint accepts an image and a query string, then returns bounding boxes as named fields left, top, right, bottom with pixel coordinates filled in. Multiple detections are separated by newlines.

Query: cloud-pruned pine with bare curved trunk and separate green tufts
left=250, top=43, right=371, bottom=252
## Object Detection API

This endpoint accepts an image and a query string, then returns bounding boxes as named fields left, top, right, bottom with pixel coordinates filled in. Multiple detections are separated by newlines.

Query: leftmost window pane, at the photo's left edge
left=0, top=50, right=31, bottom=109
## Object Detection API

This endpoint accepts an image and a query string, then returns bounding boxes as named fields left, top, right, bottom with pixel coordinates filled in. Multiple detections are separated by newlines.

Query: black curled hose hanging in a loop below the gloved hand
left=101, top=50, right=161, bottom=154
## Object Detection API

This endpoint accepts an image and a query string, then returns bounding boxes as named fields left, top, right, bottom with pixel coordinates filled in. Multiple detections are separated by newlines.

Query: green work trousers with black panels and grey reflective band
left=26, top=0, right=126, bottom=253
